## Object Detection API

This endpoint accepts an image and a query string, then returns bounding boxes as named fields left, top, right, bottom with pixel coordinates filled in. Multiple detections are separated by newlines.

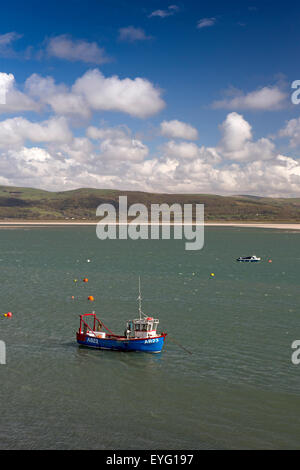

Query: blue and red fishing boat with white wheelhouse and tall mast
left=76, top=280, right=167, bottom=353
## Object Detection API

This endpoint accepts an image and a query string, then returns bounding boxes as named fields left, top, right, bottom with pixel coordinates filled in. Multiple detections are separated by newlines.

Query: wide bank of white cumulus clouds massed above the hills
left=0, top=107, right=300, bottom=197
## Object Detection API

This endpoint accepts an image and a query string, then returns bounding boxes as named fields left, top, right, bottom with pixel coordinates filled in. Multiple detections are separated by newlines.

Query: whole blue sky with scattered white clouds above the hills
left=0, top=0, right=300, bottom=197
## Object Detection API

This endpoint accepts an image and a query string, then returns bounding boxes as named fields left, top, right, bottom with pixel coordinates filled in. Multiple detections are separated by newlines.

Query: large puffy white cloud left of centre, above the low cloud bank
left=25, top=69, right=165, bottom=118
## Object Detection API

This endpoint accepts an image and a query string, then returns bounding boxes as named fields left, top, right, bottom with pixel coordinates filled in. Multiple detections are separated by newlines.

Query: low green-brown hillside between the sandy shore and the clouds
left=0, top=186, right=300, bottom=223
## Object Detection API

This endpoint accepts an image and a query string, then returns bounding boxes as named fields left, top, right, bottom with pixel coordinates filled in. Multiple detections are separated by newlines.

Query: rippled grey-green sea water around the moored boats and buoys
left=0, top=227, right=300, bottom=450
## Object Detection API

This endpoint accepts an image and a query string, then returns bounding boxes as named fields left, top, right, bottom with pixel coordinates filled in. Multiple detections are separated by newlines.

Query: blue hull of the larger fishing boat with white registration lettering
left=77, top=334, right=166, bottom=353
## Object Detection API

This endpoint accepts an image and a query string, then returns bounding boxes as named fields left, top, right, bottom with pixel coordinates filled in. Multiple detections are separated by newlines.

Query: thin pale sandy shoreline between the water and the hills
left=0, top=220, right=300, bottom=230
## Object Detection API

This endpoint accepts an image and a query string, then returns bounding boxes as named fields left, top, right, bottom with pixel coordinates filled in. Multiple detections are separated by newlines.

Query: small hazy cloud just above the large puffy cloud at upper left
left=46, top=34, right=108, bottom=64
